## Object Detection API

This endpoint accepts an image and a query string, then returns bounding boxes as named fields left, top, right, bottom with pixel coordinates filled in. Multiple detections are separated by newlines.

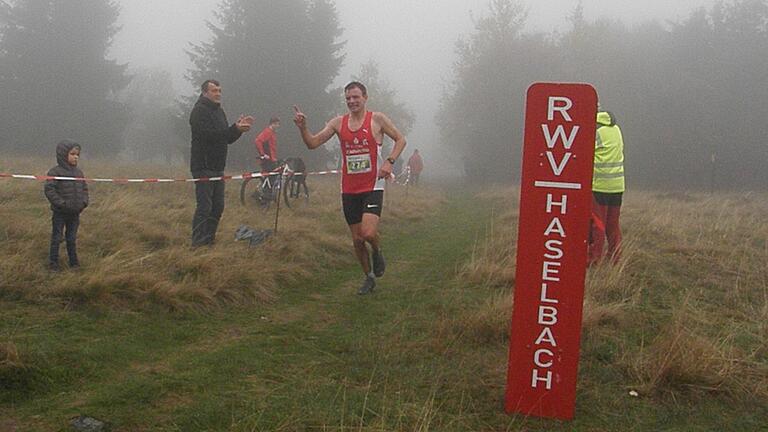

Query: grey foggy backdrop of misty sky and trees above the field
left=6, top=0, right=768, bottom=189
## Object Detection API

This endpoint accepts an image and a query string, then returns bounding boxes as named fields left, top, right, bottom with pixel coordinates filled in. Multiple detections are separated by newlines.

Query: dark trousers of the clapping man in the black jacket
left=192, top=171, right=224, bottom=246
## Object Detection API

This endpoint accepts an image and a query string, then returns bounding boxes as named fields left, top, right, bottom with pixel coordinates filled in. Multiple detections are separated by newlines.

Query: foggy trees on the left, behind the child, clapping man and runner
left=0, top=0, right=413, bottom=168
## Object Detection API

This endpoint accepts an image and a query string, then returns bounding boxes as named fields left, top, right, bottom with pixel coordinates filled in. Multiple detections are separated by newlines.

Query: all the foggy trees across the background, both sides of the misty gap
left=0, top=0, right=768, bottom=189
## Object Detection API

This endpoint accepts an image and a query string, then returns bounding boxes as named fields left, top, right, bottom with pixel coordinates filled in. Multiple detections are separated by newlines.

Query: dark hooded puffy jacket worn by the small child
left=43, top=140, right=88, bottom=214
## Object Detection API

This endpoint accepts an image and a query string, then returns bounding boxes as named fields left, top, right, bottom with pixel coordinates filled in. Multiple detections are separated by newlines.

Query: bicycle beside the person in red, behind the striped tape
left=240, top=158, right=309, bottom=211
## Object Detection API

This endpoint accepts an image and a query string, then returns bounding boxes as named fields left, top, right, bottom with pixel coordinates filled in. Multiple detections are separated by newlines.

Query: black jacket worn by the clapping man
left=189, top=96, right=242, bottom=176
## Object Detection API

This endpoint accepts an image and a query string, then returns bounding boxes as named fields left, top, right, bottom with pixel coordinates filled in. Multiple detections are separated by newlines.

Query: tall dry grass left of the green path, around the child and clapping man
left=0, top=158, right=439, bottom=310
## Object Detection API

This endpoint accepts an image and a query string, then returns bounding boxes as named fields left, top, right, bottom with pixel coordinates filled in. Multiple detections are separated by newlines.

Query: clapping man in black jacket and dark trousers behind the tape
left=189, top=79, right=253, bottom=247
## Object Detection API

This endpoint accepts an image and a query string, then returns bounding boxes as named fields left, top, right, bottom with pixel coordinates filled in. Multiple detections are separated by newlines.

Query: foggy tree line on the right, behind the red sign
left=437, top=0, right=768, bottom=189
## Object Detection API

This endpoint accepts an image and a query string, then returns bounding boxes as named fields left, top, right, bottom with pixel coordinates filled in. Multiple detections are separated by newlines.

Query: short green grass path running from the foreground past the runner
left=0, top=192, right=768, bottom=432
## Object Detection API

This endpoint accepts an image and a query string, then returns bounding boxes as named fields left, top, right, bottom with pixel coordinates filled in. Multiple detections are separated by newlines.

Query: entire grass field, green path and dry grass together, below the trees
left=0, top=161, right=768, bottom=432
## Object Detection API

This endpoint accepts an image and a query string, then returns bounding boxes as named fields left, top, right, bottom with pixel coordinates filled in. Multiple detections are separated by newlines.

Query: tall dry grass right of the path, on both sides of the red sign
left=454, top=190, right=768, bottom=400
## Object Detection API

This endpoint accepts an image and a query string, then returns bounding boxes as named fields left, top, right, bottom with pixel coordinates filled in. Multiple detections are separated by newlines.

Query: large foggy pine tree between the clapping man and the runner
left=186, top=0, right=344, bottom=168
